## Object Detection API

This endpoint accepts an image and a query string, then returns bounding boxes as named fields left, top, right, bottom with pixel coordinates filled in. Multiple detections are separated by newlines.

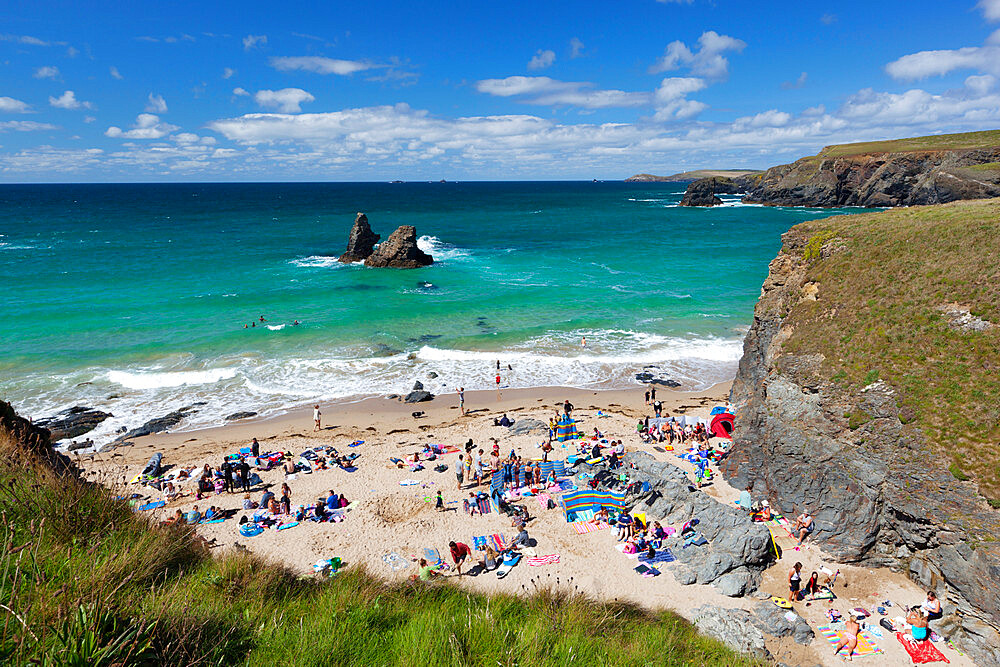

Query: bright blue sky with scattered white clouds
left=0, top=0, right=1000, bottom=182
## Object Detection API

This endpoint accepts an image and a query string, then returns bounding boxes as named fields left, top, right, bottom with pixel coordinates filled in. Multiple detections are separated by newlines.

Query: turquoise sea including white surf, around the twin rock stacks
left=0, top=182, right=856, bottom=442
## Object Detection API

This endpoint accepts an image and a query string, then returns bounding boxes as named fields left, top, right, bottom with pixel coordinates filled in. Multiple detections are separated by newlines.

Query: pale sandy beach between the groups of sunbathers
left=81, top=383, right=973, bottom=665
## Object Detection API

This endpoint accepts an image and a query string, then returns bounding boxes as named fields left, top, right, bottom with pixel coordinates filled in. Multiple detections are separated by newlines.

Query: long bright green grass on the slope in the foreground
left=0, top=432, right=754, bottom=667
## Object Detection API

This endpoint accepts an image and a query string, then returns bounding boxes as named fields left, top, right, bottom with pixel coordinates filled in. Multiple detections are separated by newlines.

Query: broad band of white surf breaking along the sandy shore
left=11, top=329, right=741, bottom=452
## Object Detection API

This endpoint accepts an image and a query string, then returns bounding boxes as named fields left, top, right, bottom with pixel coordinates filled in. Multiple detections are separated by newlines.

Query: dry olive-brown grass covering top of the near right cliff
left=784, top=198, right=1000, bottom=503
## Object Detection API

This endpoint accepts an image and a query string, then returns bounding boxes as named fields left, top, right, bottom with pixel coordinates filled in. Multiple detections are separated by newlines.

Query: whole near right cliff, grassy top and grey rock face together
left=723, top=199, right=1000, bottom=665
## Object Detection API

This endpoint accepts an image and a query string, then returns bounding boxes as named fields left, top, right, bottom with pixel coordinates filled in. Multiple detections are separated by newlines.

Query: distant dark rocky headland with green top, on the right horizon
left=744, top=147, right=1000, bottom=207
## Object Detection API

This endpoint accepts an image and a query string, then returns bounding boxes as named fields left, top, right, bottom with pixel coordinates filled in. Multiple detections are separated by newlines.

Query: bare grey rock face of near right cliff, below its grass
left=722, top=228, right=1000, bottom=666
